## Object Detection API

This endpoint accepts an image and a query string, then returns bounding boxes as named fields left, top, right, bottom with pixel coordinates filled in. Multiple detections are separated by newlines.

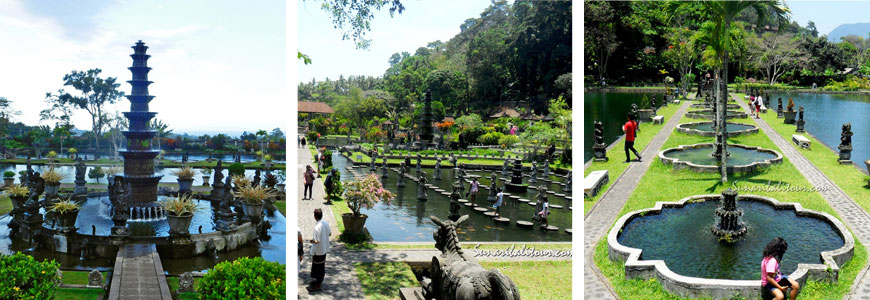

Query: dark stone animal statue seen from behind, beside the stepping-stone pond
left=420, top=215, right=520, bottom=300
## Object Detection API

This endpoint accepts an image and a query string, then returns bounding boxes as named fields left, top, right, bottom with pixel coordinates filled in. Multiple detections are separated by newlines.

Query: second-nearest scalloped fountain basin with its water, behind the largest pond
left=659, top=143, right=782, bottom=173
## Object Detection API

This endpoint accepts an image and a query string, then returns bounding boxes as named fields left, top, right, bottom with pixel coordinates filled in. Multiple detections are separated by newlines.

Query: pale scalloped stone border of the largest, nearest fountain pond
left=607, top=194, right=855, bottom=299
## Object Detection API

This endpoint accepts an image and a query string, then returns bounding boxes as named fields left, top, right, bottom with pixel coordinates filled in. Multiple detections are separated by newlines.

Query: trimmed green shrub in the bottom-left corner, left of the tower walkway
left=0, top=252, right=61, bottom=299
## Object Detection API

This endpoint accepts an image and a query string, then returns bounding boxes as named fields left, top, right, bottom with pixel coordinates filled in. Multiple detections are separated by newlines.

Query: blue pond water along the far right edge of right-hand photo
left=770, top=93, right=870, bottom=169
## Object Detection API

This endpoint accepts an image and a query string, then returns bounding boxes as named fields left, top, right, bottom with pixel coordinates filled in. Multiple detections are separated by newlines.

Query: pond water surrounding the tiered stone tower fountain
left=0, top=202, right=287, bottom=274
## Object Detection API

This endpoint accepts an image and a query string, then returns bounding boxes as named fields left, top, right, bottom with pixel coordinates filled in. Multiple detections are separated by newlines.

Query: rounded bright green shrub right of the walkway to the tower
left=197, top=257, right=287, bottom=299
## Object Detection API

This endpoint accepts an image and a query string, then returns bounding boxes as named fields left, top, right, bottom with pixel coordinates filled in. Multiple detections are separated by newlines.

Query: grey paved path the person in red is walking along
left=583, top=101, right=692, bottom=299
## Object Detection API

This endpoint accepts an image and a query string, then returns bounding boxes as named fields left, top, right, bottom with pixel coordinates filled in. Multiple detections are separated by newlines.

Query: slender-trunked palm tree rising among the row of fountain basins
left=669, top=0, right=789, bottom=183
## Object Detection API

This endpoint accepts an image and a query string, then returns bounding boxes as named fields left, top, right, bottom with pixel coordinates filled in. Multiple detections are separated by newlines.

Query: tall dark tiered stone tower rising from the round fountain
left=120, top=40, right=163, bottom=207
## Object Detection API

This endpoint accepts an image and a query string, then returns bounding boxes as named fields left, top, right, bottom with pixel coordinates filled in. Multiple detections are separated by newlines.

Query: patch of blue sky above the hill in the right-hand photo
left=786, top=1, right=870, bottom=38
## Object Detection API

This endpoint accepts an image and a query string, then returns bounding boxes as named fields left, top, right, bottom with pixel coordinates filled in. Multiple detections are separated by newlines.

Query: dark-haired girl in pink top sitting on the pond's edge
left=761, top=237, right=800, bottom=300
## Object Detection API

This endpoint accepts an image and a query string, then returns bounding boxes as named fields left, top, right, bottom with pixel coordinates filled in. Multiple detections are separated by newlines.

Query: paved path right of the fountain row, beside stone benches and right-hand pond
left=735, top=97, right=870, bottom=299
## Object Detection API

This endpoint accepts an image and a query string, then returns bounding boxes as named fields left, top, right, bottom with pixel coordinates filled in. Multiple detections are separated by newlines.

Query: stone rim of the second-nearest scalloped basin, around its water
left=659, top=143, right=782, bottom=173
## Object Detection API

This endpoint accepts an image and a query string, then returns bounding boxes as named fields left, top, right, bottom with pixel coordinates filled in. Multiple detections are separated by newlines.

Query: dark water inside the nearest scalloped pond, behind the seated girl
left=618, top=201, right=844, bottom=280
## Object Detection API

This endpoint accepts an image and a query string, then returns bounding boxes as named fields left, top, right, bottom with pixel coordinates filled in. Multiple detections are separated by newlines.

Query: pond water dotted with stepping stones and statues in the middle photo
left=333, top=154, right=572, bottom=242
